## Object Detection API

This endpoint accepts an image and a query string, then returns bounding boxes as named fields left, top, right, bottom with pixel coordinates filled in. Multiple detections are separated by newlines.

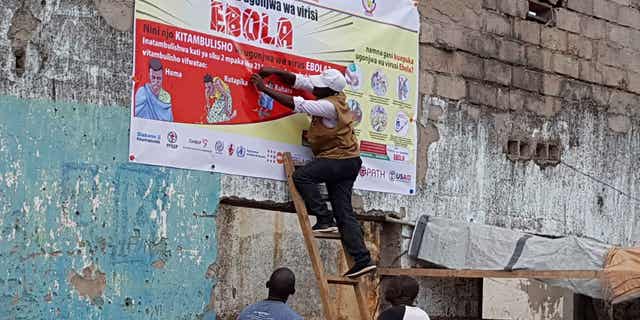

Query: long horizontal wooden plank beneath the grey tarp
left=378, top=268, right=602, bottom=279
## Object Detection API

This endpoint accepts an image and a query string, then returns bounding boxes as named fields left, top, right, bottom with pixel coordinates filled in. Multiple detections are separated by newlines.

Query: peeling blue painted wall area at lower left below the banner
left=0, top=97, right=220, bottom=319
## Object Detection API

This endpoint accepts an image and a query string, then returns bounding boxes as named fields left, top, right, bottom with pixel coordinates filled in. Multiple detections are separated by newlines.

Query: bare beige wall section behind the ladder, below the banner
left=212, top=206, right=380, bottom=320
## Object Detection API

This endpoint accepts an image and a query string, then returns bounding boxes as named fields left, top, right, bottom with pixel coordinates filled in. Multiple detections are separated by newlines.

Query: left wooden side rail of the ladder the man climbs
left=284, top=152, right=336, bottom=320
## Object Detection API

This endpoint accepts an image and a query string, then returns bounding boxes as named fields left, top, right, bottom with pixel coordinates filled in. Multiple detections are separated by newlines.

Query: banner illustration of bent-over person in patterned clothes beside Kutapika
left=203, top=74, right=237, bottom=123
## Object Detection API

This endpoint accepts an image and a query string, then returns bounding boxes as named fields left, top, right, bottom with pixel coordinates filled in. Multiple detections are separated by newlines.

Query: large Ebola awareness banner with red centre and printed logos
left=129, top=0, right=419, bottom=194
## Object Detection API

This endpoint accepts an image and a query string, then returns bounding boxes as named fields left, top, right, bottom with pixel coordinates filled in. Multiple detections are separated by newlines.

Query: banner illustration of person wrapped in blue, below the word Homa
left=134, top=59, right=173, bottom=122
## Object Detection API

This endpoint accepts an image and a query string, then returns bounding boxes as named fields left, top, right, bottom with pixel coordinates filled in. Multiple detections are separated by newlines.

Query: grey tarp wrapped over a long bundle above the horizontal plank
left=409, top=216, right=611, bottom=299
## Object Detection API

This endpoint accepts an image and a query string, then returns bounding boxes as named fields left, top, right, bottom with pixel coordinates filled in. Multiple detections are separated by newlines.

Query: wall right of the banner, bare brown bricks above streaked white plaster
left=400, top=0, right=640, bottom=245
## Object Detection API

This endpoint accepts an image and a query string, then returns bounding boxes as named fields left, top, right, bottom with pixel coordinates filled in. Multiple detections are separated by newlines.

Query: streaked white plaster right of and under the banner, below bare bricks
left=221, top=94, right=640, bottom=245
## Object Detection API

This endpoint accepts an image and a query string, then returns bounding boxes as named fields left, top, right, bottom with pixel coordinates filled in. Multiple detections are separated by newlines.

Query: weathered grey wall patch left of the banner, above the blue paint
left=0, top=0, right=133, bottom=107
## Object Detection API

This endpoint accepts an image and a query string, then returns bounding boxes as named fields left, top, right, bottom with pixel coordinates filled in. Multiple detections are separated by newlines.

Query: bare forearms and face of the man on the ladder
left=251, top=67, right=338, bottom=110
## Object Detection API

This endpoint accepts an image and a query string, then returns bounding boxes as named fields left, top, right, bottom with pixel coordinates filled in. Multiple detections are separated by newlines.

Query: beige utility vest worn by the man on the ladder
left=307, top=92, right=360, bottom=159
